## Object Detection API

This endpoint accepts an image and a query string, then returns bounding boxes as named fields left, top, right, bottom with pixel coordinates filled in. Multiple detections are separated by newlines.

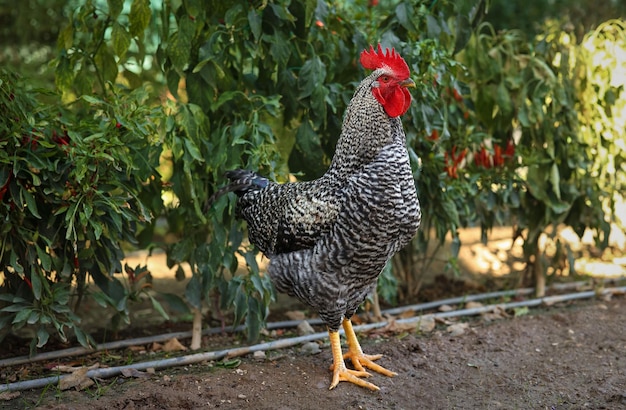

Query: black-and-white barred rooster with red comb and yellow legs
left=210, top=45, right=421, bottom=390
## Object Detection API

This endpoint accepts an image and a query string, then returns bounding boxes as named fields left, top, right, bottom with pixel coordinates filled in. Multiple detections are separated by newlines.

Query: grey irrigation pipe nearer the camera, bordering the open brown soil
left=0, top=286, right=626, bottom=393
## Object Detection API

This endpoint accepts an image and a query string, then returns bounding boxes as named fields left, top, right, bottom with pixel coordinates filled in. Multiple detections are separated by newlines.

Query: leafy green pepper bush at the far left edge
left=0, top=71, right=165, bottom=351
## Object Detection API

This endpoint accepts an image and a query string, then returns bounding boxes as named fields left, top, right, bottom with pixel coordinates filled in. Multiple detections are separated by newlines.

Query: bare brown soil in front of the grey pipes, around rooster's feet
left=0, top=296, right=626, bottom=409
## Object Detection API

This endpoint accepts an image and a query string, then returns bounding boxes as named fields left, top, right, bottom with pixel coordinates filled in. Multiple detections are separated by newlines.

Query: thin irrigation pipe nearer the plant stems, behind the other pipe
left=0, top=279, right=616, bottom=368
